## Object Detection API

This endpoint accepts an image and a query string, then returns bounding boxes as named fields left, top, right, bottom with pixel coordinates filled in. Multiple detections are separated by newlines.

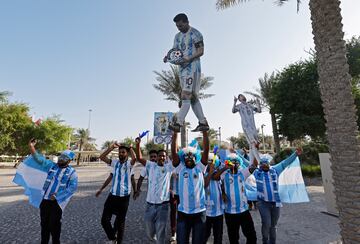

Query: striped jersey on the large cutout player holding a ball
left=173, top=27, right=203, bottom=75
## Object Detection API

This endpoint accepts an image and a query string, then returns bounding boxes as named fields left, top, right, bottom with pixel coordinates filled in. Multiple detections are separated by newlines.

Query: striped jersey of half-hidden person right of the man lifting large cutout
left=205, top=167, right=224, bottom=217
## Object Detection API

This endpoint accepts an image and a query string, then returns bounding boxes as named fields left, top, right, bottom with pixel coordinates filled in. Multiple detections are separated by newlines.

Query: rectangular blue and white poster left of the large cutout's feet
left=154, top=112, right=174, bottom=144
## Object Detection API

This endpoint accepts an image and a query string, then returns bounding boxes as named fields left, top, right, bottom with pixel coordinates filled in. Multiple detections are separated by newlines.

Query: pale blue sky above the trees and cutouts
left=0, top=0, right=360, bottom=145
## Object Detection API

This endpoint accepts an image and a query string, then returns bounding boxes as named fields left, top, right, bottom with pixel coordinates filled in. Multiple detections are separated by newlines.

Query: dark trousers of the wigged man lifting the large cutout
left=176, top=211, right=206, bottom=244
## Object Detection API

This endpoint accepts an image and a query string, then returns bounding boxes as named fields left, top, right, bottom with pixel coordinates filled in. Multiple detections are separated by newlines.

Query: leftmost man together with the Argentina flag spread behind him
left=13, top=139, right=78, bottom=244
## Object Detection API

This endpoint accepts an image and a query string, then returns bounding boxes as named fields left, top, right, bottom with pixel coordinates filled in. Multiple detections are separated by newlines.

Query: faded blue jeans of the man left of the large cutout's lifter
left=144, top=202, right=170, bottom=244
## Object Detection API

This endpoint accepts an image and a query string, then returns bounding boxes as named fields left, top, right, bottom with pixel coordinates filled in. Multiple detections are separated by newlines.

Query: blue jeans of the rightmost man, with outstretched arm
left=258, top=200, right=280, bottom=244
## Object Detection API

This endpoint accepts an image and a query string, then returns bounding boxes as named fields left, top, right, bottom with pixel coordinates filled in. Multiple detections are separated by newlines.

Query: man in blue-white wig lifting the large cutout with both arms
left=171, top=131, right=209, bottom=244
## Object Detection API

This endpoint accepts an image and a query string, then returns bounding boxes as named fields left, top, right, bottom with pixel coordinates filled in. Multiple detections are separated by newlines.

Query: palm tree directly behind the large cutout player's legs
left=153, top=65, right=214, bottom=147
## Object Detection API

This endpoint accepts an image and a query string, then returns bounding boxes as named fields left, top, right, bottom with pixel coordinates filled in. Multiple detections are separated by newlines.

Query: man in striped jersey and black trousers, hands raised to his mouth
left=214, top=153, right=257, bottom=244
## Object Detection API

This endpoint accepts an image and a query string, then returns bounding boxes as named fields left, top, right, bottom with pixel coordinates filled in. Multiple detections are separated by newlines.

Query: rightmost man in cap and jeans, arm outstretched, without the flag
left=254, top=149, right=302, bottom=244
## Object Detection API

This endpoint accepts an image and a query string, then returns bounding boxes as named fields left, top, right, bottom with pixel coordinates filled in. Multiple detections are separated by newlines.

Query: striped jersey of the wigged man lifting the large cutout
left=175, top=163, right=206, bottom=214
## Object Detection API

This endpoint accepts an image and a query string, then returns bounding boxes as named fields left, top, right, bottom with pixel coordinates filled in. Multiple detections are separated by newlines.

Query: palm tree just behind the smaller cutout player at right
left=245, top=72, right=280, bottom=153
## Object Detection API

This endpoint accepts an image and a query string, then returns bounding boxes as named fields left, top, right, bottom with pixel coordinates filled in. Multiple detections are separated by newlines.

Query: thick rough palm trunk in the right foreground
left=309, top=0, right=360, bottom=243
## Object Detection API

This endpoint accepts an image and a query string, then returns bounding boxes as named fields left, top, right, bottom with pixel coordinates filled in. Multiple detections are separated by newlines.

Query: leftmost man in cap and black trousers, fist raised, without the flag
left=29, top=139, right=78, bottom=244
